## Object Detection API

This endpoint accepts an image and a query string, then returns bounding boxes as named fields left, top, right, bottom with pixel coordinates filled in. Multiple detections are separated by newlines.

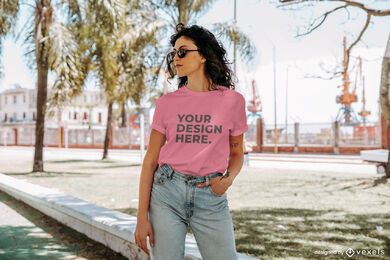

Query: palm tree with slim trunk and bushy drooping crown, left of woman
left=74, top=0, right=159, bottom=159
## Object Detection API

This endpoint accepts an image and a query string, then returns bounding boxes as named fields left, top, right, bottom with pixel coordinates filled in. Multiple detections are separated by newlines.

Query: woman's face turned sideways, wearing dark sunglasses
left=173, top=36, right=206, bottom=77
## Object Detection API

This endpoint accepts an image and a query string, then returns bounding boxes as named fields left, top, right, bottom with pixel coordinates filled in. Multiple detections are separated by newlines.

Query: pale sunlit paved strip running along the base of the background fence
left=0, top=146, right=376, bottom=173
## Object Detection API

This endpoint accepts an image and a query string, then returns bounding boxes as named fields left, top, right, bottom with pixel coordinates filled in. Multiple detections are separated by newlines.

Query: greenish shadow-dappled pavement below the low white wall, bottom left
left=0, top=192, right=125, bottom=260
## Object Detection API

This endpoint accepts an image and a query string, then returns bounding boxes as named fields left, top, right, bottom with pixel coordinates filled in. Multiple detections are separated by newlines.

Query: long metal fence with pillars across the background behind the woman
left=0, top=120, right=381, bottom=148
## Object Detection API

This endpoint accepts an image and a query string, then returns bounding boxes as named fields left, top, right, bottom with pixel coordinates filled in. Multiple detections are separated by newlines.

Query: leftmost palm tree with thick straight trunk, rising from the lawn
left=0, top=0, right=85, bottom=172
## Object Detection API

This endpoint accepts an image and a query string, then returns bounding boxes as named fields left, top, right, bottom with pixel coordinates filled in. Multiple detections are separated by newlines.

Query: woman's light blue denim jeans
left=149, top=164, right=237, bottom=260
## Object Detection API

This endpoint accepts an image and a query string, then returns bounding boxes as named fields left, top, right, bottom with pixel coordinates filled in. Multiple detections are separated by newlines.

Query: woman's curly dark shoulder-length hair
left=166, top=23, right=235, bottom=90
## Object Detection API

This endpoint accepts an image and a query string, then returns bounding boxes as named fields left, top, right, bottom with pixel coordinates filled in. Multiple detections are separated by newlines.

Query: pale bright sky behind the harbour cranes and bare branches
left=0, top=0, right=390, bottom=124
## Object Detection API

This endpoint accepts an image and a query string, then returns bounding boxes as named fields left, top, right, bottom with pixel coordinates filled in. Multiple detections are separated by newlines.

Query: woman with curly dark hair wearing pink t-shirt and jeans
left=135, top=24, right=247, bottom=260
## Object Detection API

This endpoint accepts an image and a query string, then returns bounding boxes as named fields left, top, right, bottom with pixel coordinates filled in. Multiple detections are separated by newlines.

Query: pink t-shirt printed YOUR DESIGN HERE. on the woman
left=151, top=86, right=248, bottom=176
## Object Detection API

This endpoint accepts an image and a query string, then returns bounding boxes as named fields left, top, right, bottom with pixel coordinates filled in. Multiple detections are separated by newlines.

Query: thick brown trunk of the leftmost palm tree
left=33, top=58, right=48, bottom=172
